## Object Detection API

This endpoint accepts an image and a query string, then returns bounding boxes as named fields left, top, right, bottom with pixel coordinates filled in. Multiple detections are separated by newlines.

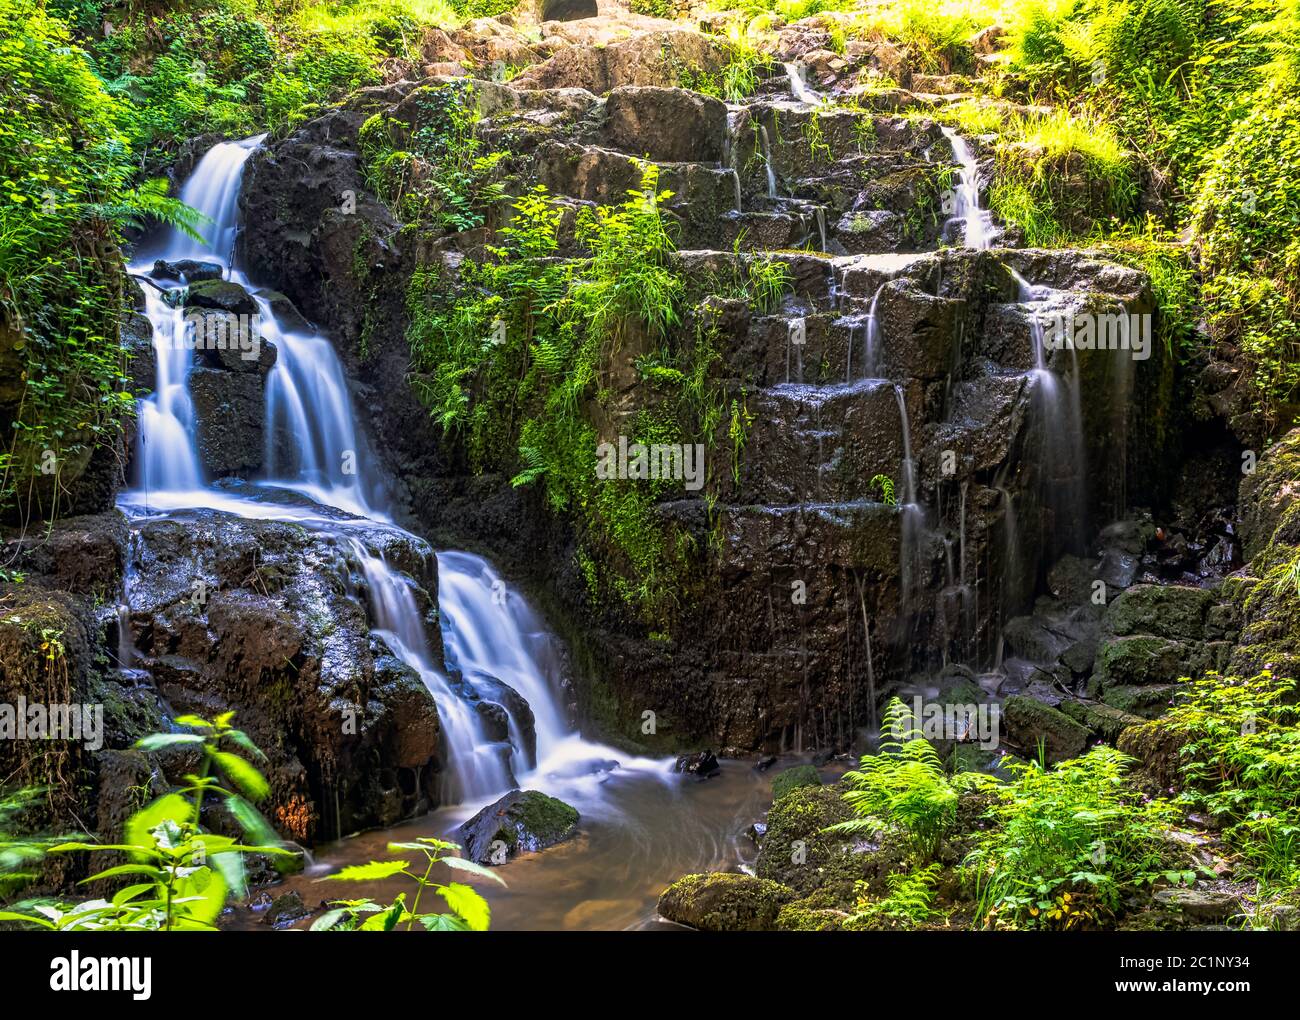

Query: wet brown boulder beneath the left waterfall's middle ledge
left=0, top=511, right=442, bottom=843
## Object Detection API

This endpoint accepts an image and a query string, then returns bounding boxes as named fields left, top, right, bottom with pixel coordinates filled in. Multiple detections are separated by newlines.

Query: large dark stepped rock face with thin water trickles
left=233, top=31, right=1190, bottom=750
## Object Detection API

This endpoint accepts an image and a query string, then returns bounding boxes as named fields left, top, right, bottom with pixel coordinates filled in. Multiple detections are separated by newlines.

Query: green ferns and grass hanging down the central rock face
left=408, top=165, right=720, bottom=621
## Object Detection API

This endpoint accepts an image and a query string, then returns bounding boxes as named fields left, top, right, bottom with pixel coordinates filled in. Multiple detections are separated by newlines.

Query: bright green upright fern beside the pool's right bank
left=829, top=698, right=989, bottom=863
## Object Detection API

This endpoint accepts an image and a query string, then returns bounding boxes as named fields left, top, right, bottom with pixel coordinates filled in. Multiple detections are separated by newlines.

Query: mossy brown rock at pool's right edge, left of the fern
left=755, top=785, right=870, bottom=906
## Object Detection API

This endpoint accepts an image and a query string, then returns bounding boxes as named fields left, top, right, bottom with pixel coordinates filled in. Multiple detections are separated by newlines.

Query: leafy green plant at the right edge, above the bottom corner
left=1158, top=672, right=1300, bottom=886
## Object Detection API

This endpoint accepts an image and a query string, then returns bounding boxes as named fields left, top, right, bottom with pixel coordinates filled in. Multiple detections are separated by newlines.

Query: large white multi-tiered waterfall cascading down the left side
left=118, top=131, right=647, bottom=802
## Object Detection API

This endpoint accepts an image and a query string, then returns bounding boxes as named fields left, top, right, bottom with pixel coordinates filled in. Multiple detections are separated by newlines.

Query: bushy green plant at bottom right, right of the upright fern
left=966, top=745, right=1195, bottom=928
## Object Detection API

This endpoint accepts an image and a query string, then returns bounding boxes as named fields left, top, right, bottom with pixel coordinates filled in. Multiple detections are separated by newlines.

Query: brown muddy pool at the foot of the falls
left=224, top=756, right=842, bottom=932
